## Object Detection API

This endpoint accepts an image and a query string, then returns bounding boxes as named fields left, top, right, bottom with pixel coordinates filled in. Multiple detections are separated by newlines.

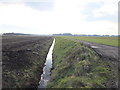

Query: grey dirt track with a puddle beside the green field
left=80, top=41, right=118, bottom=60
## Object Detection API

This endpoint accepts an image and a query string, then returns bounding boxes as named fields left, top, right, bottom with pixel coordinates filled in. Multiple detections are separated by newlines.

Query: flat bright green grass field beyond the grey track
left=61, top=36, right=120, bottom=46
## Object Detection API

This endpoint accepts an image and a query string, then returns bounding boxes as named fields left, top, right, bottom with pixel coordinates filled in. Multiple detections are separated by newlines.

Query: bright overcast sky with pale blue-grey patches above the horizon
left=0, top=0, right=119, bottom=35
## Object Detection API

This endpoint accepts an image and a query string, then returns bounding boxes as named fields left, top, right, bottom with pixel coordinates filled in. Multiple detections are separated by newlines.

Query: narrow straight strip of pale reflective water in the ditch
left=38, top=39, right=55, bottom=88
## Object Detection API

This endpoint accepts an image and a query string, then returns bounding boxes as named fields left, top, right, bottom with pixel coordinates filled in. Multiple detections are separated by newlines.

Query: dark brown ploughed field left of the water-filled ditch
left=2, top=35, right=53, bottom=88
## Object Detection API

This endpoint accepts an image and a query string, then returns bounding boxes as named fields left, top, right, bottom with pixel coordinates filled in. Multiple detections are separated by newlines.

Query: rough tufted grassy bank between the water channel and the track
left=48, top=37, right=117, bottom=88
